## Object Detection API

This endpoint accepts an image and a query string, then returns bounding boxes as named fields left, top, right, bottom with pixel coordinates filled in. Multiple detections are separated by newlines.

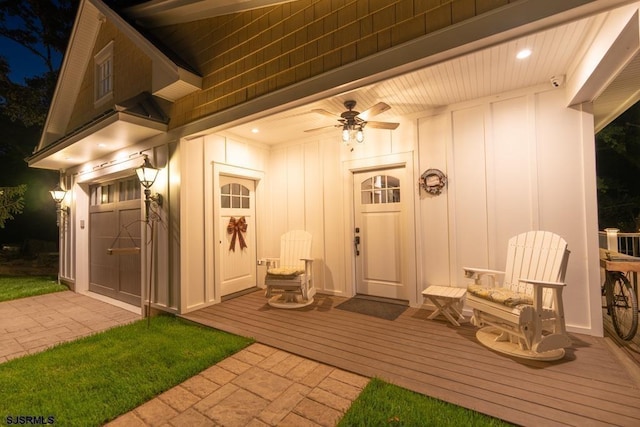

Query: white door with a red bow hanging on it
left=218, top=175, right=257, bottom=296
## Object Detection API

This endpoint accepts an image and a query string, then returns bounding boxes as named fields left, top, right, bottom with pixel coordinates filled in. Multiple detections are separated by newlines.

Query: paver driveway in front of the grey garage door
left=0, top=291, right=140, bottom=363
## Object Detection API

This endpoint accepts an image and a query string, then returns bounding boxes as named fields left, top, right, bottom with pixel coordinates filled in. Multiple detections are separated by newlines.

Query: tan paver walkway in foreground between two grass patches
left=107, top=344, right=369, bottom=427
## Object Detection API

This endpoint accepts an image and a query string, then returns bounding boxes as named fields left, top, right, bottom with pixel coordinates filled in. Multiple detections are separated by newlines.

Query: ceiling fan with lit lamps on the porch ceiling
left=305, top=100, right=400, bottom=144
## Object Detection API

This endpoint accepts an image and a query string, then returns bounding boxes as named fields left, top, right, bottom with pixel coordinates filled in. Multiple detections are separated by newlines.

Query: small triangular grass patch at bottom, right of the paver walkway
left=338, top=378, right=511, bottom=427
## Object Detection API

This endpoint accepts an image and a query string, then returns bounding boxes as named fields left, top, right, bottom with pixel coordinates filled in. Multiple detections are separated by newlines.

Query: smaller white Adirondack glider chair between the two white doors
left=265, top=230, right=316, bottom=308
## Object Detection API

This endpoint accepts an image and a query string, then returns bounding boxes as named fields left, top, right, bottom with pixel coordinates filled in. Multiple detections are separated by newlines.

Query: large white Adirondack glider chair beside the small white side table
left=464, top=231, right=571, bottom=360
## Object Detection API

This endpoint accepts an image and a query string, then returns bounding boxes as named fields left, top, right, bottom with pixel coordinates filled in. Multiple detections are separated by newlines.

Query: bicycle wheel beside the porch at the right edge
left=602, top=270, right=638, bottom=341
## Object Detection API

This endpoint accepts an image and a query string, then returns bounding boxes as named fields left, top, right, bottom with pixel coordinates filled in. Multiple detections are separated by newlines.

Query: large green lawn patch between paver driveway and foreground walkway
left=0, top=316, right=252, bottom=426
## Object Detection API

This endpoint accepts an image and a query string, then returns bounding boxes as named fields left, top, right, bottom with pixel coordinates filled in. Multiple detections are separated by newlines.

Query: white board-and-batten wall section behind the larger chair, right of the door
left=418, top=90, right=601, bottom=335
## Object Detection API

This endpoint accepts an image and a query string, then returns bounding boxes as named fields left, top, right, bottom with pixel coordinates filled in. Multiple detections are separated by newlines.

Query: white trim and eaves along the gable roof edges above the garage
left=35, top=0, right=202, bottom=157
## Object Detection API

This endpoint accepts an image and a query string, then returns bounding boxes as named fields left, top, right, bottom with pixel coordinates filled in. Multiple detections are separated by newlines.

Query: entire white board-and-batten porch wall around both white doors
left=181, top=86, right=601, bottom=335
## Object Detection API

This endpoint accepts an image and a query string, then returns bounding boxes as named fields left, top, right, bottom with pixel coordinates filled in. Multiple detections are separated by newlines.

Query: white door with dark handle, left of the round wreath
left=353, top=167, right=415, bottom=300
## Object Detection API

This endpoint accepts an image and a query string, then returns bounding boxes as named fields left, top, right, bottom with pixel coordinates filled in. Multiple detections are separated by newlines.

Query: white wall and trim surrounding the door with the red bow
left=180, top=135, right=267, bottom=313
